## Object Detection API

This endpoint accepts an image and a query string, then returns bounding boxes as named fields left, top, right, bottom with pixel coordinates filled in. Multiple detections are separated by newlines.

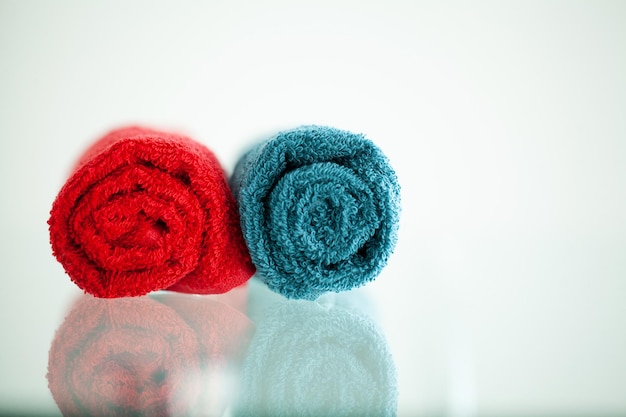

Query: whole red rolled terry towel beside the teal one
left=48, top=127, right=254, bottom=298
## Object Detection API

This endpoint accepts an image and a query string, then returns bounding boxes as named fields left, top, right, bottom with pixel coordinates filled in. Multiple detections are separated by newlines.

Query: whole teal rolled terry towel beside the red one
left=231, top=126, right=400, bottom=300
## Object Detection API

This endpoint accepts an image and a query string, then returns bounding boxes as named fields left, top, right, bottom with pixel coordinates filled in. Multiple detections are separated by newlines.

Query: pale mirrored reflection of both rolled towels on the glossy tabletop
left=46, top=280, right=397, bottom=416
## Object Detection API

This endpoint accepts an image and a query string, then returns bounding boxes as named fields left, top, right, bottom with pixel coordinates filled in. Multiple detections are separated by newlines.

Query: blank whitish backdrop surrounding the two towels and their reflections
left=0, top=0, right=626, bottom=416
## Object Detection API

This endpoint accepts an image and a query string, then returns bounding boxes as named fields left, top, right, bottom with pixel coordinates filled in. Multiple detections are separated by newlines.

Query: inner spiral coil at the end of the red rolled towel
left=72, top=165, right=202, bottom=271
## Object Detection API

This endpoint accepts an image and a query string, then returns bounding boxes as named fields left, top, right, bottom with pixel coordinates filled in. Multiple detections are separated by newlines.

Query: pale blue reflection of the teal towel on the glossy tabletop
left=234, top=280, right=397, bottom=417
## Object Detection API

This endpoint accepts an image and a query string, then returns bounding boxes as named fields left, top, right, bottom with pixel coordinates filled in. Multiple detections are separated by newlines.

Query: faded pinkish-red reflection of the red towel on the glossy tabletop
left=47, top=293, right=252, bottom=417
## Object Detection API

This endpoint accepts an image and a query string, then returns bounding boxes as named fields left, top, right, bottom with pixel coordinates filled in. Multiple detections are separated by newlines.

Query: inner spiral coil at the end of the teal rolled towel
left=269, top=162, right=380, bottom=269
